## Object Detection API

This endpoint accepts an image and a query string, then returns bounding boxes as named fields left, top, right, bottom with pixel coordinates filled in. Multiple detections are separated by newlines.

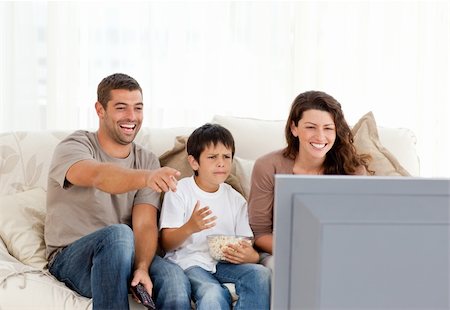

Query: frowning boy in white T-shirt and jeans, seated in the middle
left=160, top=124, right=271, bottom=310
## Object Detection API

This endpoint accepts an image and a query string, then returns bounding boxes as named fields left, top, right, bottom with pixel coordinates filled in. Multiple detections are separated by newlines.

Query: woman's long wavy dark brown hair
left=283, top=91, right=371, bottom=175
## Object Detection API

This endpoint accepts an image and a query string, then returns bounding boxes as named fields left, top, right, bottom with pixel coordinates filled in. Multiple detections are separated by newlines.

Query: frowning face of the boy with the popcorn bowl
left=188, top=142, right=232, bottom=193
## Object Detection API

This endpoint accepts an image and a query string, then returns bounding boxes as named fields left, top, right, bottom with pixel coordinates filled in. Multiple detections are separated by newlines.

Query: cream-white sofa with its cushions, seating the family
left=0, top=113, right=420, bottom=310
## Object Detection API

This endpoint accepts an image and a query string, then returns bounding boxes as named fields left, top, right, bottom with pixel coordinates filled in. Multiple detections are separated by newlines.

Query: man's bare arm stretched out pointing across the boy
left=66, top=160, right=180, bottom=194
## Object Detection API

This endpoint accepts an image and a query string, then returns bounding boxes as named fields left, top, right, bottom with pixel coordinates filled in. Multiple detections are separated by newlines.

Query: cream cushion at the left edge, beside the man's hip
left=0, top=188, right=47, bottom=269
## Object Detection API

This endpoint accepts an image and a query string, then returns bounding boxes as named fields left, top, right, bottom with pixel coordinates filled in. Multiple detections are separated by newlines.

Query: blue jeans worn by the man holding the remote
left=49, top=224, right=190, bottom=310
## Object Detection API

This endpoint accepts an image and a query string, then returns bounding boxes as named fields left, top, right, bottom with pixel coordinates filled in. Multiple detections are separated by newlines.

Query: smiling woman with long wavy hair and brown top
left=249, top=91, right=372, bottom=269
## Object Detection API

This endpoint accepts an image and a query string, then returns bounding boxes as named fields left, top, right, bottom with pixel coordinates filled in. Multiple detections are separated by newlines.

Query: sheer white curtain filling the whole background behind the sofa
left=0, top=1, right=450, bottom=176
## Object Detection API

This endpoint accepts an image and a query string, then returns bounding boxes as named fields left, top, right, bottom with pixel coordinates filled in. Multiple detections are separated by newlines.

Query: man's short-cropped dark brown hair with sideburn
left=97, top=73, right=142, bottom=109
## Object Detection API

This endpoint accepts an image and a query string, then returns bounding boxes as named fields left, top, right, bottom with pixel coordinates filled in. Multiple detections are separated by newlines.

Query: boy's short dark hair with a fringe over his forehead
left=186, top=123, right=235, bottom=163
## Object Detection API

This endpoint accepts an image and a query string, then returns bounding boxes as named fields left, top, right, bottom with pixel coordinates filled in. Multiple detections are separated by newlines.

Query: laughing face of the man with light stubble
left=97, top=89, right=144, bottom=145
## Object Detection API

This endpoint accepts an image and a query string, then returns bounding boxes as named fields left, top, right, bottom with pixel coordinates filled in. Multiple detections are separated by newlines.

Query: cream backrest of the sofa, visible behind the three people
left=0, top=116, right=420, bottom=195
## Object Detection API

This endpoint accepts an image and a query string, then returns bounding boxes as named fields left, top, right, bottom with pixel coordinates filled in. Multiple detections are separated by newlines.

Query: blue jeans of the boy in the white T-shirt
left=184, top=262, right=271, bottom=310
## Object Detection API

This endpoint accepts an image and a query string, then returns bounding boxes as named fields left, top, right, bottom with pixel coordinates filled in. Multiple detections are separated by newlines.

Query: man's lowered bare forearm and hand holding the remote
left=131, top=204, right=158, bottom=294
